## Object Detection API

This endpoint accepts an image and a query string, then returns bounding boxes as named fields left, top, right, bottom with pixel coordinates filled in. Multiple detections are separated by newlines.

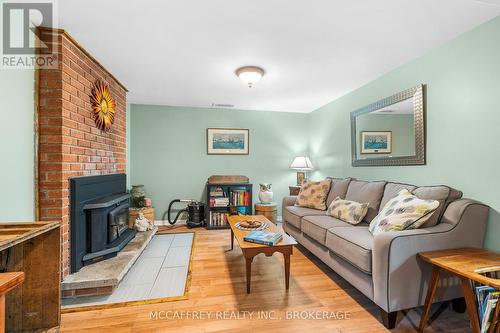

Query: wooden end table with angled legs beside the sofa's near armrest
left=418, top=248, right=500, bottom=333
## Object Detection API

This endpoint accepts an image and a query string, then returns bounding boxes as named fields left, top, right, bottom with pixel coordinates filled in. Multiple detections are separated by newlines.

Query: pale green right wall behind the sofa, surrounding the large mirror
left=309, top=17, right=500, bottom=250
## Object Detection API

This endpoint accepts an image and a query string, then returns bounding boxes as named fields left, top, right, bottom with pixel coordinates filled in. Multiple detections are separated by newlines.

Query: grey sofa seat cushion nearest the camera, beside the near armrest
left=326, top=226, right=373, bottom=274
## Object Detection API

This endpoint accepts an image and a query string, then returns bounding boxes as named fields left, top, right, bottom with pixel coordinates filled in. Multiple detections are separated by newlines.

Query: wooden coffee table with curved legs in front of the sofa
left=228, top=215, right=297, bottom=294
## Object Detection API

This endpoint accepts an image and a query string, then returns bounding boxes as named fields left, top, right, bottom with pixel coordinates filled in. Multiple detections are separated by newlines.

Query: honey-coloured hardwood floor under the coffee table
left=61, top=227, right=469, bottom=333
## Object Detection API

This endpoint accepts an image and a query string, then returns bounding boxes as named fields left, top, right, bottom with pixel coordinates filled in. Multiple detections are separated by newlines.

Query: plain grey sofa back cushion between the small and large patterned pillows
left=345, top=180, right=386, bottom=222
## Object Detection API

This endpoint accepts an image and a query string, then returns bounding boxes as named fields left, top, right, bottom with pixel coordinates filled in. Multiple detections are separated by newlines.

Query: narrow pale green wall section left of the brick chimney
left=0, top=70, right=35, bottom=221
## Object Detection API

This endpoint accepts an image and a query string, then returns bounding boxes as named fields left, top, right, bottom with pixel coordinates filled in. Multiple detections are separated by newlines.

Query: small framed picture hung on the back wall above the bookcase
left=207, top=128, right=249, bottom=155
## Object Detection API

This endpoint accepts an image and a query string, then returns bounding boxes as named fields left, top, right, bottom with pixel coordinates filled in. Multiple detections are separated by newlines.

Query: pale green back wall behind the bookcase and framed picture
left=131, top=104, right=308, bottom=219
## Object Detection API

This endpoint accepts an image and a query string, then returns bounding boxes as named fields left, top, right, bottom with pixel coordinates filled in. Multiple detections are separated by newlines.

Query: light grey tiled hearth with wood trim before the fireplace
left=62, top=233, right=194, bottom=312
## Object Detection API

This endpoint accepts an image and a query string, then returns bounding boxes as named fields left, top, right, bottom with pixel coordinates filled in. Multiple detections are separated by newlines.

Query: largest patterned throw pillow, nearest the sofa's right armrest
left=369, top=189, right=439, bottom=235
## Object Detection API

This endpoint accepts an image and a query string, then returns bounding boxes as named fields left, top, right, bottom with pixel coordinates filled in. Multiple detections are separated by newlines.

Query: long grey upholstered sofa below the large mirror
left=282, top=178, right=489, bottom=328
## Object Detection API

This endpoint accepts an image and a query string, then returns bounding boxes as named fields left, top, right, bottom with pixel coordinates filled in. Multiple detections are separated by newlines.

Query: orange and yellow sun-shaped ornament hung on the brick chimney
left=90, top=80, right=115, bottom=131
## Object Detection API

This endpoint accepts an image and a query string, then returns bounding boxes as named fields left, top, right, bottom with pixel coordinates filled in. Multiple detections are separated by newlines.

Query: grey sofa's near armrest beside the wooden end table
left=372, top=199, right=489, bottom=312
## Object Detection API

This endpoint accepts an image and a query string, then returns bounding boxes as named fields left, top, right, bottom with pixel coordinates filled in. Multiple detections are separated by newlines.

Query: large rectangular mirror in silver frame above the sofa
left=351, top=86, right=425, bottom=166
